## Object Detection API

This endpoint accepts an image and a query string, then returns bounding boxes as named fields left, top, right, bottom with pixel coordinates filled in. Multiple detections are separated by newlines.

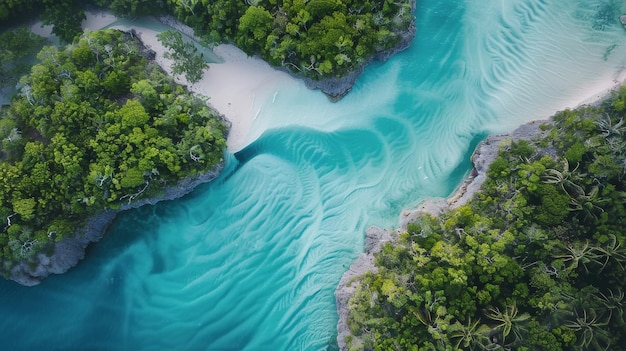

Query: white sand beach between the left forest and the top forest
left=83, top=12, right=301, bottom=152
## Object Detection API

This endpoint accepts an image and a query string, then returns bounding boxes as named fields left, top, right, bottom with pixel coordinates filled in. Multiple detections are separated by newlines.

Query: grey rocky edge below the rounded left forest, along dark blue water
left=8, top=162, right=224, bottom=286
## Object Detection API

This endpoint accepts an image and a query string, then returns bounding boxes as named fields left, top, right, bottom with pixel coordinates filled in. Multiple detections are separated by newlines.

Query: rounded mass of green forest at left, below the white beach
left=0, top=30, right=228, bottom=276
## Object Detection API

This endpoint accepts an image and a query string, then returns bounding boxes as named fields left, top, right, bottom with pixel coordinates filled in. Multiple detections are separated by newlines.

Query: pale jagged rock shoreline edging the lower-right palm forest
left=335, top=120, right=550, bottom=350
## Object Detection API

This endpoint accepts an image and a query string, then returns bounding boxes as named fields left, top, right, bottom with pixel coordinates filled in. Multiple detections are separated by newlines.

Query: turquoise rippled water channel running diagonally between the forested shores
left=0, top=0, right=626, bottom=350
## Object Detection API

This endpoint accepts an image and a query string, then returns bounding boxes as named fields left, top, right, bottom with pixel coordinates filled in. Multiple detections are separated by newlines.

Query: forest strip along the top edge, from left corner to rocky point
left=0, top=0, right=414, bottom=79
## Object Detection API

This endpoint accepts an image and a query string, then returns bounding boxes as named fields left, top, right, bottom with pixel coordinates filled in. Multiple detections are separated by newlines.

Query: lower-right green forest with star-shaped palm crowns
left=346, top=87, right=626, bottom=351
